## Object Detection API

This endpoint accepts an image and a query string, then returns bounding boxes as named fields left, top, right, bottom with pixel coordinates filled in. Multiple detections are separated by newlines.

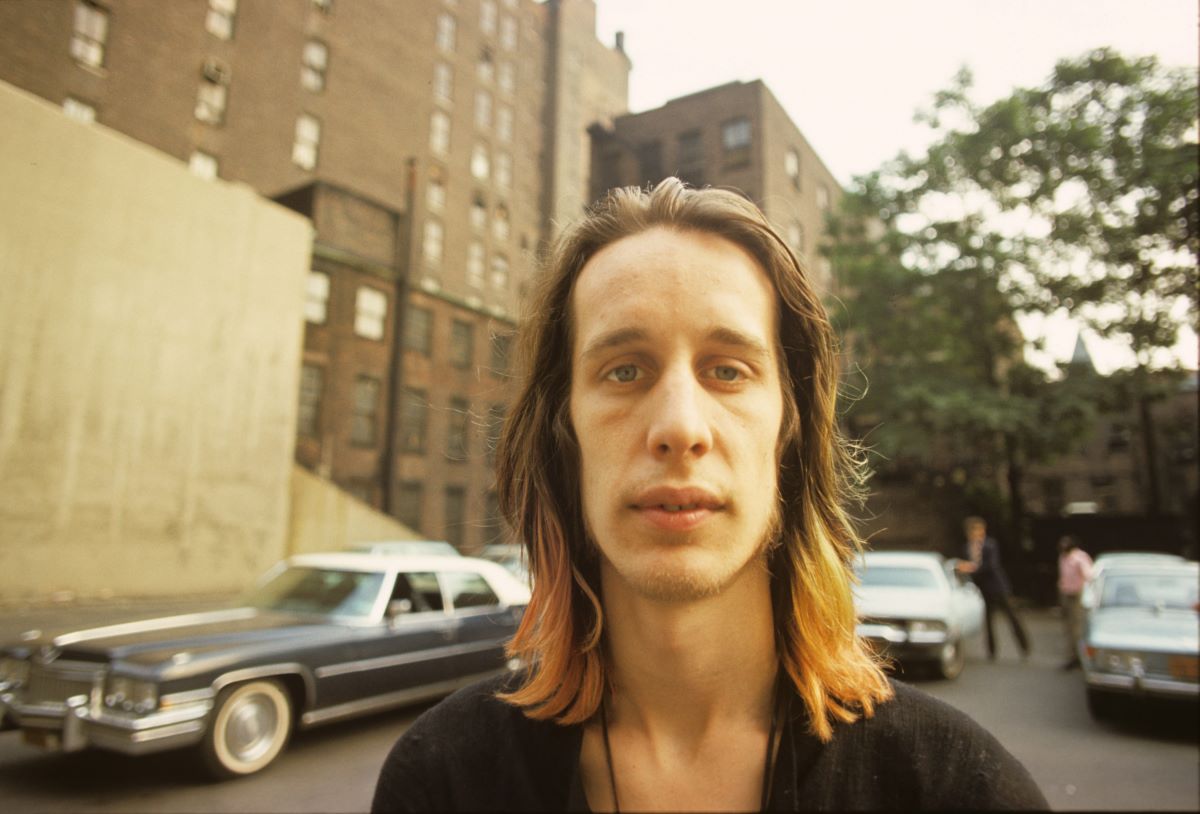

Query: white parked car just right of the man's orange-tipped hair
left=854, top=551, right=984, bottom=678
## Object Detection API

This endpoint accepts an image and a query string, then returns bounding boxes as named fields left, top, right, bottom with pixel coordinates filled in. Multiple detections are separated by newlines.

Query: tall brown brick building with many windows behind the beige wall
left=0, top=0, right=630, bottom=549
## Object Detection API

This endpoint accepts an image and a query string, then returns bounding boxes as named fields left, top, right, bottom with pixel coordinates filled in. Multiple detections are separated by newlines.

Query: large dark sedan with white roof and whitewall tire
left=0, top=552, right=529, bottom=777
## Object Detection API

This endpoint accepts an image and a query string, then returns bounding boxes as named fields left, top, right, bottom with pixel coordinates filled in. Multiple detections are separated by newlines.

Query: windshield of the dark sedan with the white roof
left=250, top=568, right=383, bottom=616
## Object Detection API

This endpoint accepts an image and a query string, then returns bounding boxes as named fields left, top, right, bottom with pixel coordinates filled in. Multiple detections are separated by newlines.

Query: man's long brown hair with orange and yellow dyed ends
left=497, top=178, right=892, bottom=740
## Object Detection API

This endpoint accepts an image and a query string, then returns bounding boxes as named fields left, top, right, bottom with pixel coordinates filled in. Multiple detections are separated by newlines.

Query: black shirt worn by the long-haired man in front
left=372, top=677, right=1049, bottom=812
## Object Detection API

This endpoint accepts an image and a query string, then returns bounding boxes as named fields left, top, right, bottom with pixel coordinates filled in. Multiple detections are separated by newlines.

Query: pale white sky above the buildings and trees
left=596, top=0, right=1200, bottom=372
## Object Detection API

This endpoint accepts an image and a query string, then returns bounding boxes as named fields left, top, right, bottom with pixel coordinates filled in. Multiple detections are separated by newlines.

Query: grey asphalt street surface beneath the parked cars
left=0, top=611, right=1200, bottom=812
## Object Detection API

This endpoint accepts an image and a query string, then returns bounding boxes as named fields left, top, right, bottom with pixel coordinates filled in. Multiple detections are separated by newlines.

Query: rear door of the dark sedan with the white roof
left=439, top=570, right=516, bottom=677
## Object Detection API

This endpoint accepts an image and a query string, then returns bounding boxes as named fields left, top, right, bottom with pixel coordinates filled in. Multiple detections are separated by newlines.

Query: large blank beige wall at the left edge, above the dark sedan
left=0, top=83, right=312, bottom=600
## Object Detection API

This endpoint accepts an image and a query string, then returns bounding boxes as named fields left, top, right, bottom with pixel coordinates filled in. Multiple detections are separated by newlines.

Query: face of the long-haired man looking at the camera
left=570, top=227, right=784, bottom=600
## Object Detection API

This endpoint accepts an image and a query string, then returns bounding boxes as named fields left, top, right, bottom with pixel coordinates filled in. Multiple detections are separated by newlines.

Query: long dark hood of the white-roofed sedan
left=38, top=607, right=360, bottom=672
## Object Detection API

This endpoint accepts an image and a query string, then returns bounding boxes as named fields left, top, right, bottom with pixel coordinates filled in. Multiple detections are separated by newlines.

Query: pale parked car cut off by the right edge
left=1079, top=559, right=1200, bottom=718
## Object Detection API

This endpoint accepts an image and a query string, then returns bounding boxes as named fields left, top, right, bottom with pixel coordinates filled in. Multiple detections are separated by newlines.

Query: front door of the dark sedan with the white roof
left=317, top=571, right=457, bottom=707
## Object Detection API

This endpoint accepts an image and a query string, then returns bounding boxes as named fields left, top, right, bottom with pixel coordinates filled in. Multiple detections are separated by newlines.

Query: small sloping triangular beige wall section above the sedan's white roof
left=288, top=466, right=421, bottom=553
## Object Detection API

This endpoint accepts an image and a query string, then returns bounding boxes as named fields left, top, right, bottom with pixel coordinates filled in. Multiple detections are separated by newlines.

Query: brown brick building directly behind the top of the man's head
left=590, top=80, right=841, bottom=292
